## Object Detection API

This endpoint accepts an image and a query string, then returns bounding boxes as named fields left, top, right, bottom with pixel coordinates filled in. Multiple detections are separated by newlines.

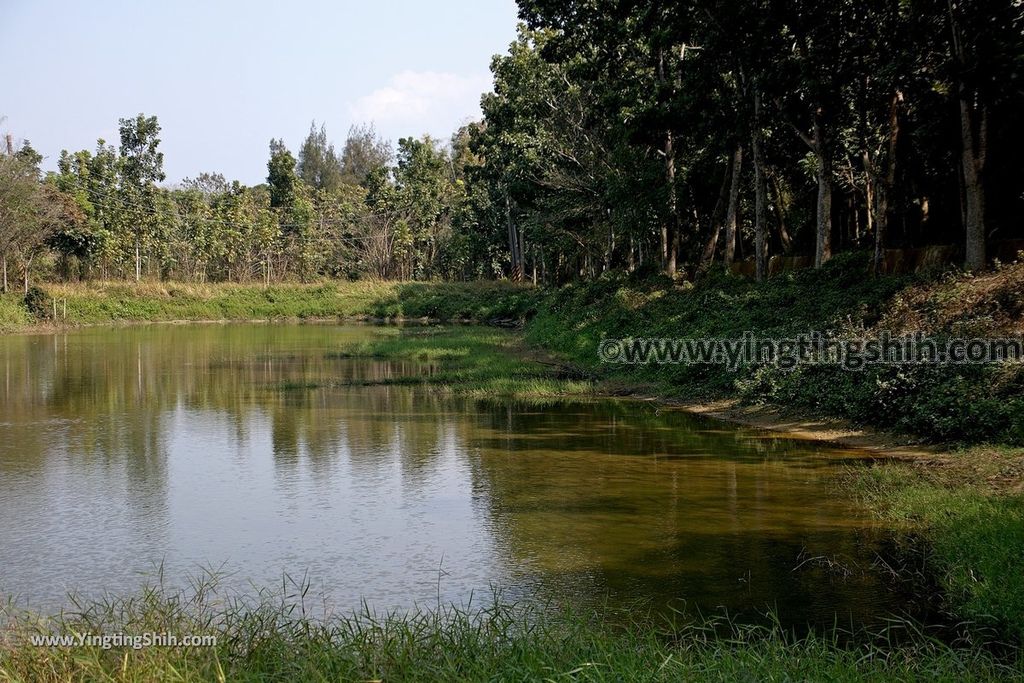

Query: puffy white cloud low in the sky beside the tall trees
left=348, top=71, right=490, bottom=135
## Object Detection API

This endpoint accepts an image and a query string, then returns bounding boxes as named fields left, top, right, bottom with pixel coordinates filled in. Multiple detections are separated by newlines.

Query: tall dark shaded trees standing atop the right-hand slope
left=482, top=0, right=1024, bottom=276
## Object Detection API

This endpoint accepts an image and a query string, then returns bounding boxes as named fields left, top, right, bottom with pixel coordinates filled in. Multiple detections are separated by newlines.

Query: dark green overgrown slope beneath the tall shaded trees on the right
left=525, top=254, right=1024, bottom=445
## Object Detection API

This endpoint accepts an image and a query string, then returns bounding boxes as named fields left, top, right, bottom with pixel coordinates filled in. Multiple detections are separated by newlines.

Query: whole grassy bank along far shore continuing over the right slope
left=9, top=254, right=1024, bottom=445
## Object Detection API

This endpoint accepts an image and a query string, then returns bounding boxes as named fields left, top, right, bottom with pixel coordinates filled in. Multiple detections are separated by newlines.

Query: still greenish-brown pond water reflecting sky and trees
left=0, top=325, right=902, bottom=625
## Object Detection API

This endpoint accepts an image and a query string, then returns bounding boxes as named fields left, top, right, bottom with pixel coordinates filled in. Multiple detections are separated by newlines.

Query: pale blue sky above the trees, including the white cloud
left=0, top=0, right=516, bottom=183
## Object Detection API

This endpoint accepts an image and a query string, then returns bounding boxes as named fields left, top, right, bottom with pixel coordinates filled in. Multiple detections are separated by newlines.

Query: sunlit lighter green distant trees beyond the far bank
left=0, top=115, right=494, bottom=291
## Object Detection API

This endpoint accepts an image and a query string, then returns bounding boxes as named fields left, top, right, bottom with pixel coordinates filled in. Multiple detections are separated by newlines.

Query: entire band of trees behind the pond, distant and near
left=0, top=0, right=1024, bottom=291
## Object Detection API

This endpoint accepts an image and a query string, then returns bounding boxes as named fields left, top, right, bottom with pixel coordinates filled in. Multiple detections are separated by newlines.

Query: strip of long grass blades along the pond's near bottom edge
left=0, top=580, right=1024, bottom=683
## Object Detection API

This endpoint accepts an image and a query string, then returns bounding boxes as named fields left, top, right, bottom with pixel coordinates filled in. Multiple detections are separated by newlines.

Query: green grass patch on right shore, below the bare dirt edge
left=856, top=447, right=1024, bottom=642
